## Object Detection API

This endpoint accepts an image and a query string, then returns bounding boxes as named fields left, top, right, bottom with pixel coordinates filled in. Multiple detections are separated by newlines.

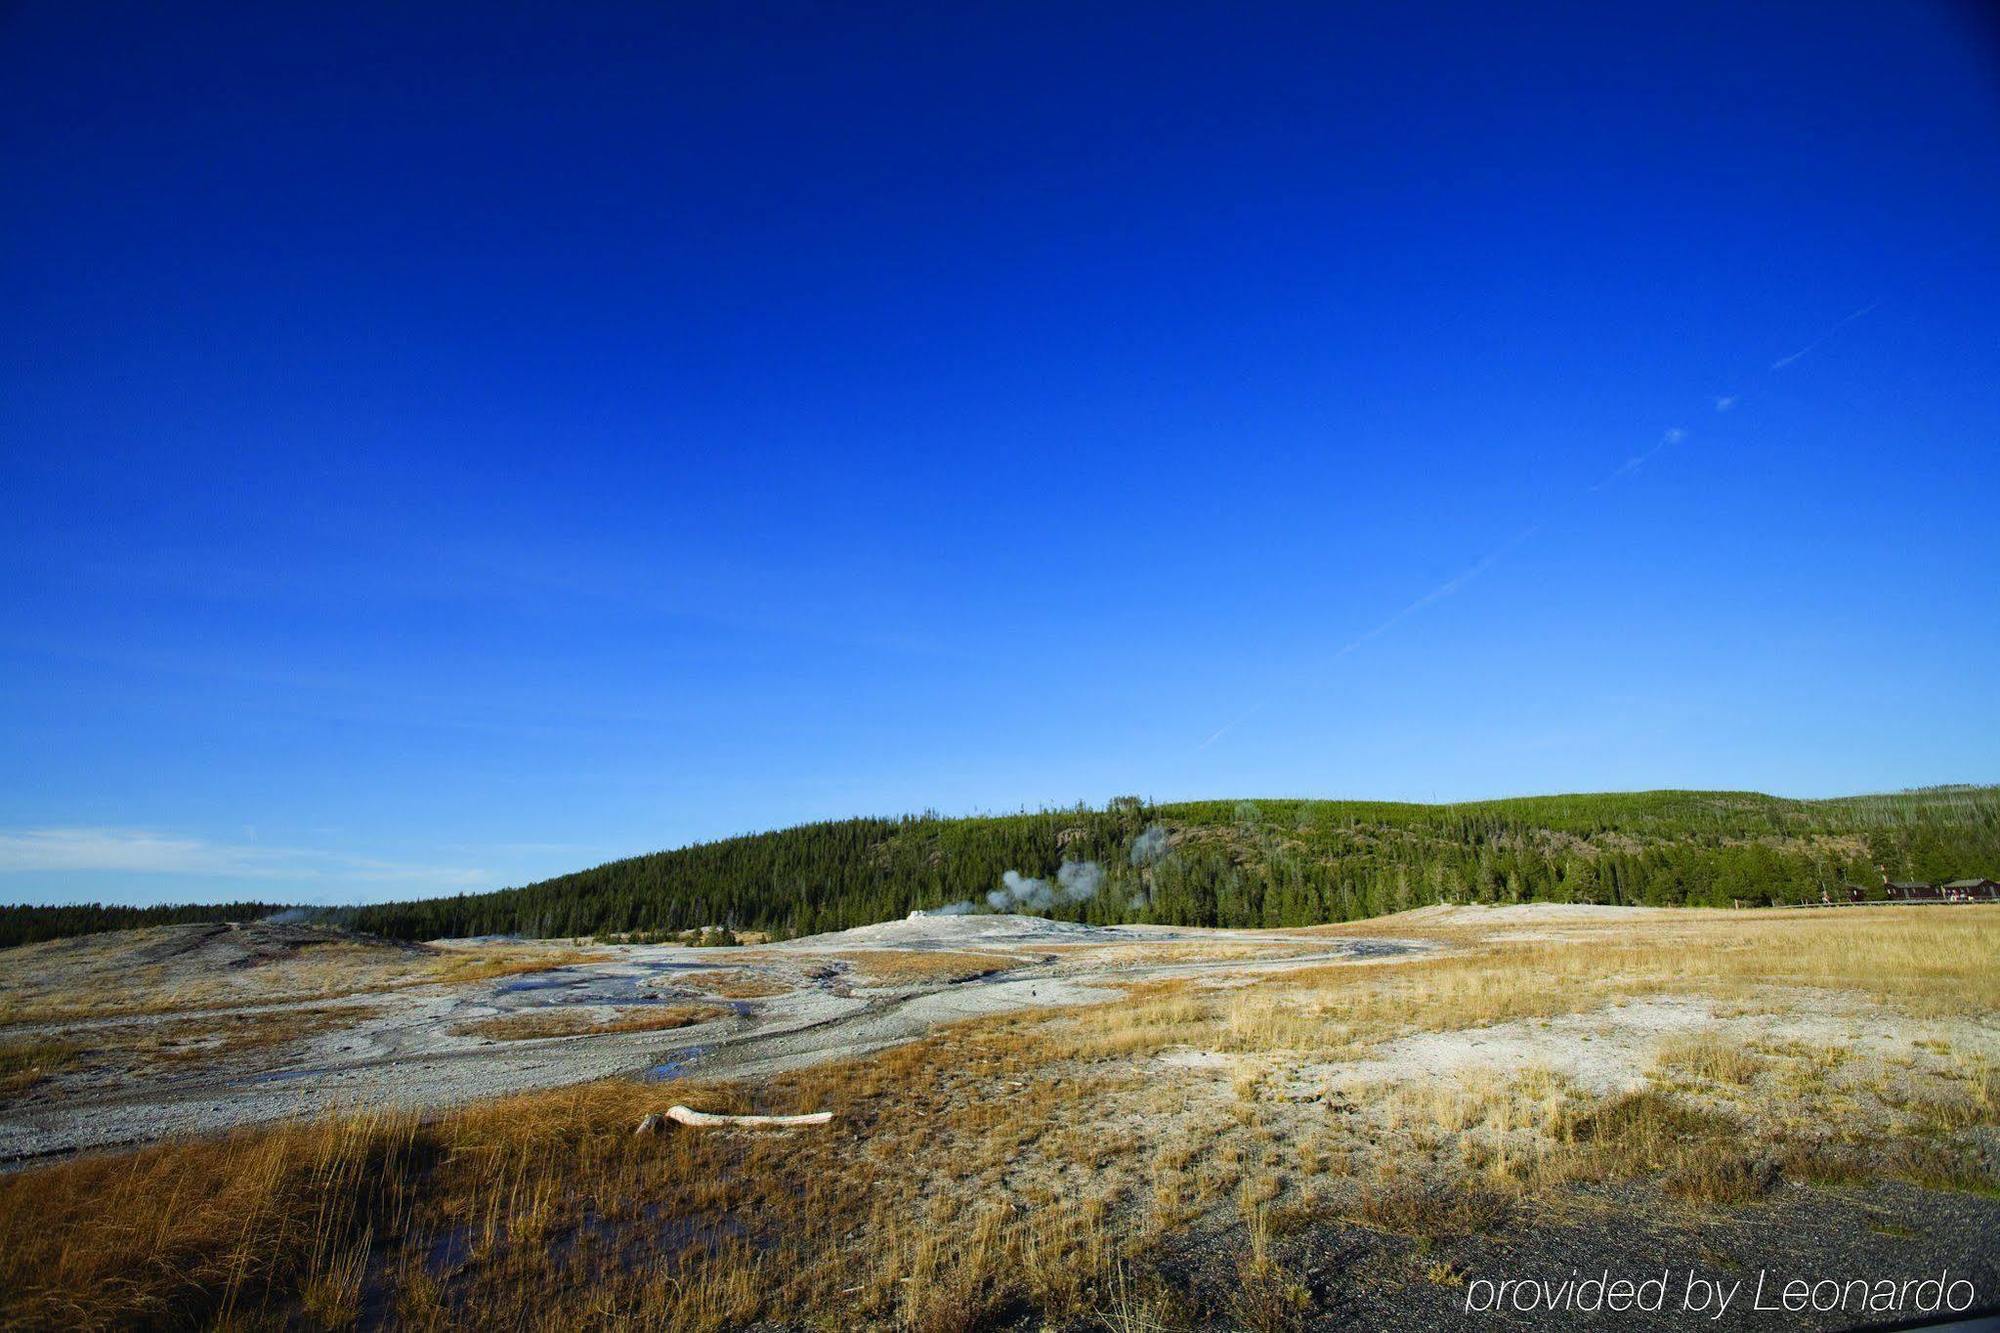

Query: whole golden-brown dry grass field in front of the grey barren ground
left=0, top=909, right=2000, bottom=1329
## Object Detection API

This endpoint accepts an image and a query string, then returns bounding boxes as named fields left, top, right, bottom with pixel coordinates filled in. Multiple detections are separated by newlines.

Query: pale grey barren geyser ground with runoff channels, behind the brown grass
left=0, top=917, right=1426, bottom=1165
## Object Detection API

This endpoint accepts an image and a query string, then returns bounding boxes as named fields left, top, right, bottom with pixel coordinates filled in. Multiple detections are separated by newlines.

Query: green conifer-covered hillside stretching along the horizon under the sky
left=0, top=787, right=2000, bottom=943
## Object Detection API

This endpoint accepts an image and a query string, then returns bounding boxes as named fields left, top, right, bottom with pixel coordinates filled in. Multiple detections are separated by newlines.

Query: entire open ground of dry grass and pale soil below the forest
left=0, top=907, right=2000, bottom=1329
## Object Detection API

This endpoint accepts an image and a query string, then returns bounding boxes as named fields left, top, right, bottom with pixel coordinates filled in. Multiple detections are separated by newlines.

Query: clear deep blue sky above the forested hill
left=0, top=2, right=2000, bottom=901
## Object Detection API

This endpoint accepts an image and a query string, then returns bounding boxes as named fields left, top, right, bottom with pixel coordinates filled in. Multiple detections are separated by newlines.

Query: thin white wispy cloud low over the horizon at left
left=0, top=827, right=490, bottom=889
